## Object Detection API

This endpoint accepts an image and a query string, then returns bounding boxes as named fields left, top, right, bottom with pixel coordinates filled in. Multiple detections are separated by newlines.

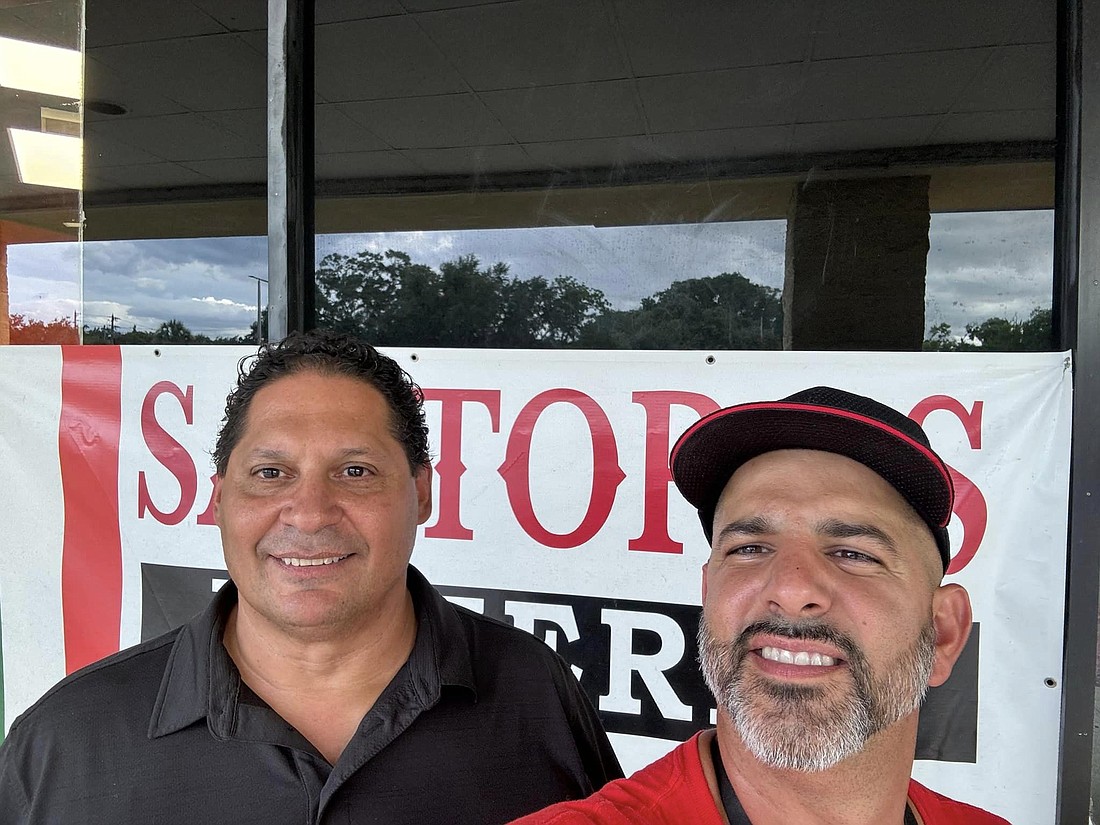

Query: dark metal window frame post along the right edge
left=1051, top=0, right=1100, bottom=825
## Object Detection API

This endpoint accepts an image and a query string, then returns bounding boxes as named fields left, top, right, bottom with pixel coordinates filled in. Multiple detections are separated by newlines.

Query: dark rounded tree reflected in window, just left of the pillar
left=581, top=272, right=783, bottom=350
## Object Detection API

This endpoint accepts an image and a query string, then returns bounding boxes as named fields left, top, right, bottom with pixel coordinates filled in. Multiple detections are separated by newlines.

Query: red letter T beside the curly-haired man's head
left=424, top=389, right=501, bottom=541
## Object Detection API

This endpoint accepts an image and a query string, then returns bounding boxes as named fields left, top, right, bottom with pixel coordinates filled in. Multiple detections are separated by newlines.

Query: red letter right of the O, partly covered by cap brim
left=627, top=389, right=718, bottom=553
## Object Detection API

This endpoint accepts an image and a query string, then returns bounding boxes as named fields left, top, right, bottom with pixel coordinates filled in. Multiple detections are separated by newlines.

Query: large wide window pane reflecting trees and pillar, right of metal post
left=315, top=0, right=1055, bottom=350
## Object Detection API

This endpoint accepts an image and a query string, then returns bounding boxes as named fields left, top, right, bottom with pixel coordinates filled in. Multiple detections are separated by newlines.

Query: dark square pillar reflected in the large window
left=783, top=176, right=928, bottom=350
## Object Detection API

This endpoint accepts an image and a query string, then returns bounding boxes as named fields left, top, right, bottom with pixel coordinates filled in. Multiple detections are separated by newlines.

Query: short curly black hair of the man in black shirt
left=213, top=330, right=431, bottom=476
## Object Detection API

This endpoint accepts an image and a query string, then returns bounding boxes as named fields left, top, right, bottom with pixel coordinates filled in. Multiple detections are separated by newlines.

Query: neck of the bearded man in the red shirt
left=704, top=714, right=916, bottom=825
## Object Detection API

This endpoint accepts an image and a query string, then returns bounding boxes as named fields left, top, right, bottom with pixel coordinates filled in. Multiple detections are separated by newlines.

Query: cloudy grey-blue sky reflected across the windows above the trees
left=8, top=211, right=1054, bottom=337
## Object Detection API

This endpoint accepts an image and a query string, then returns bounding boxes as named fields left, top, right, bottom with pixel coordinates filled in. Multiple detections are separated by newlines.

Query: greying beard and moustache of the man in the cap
left=699, top=616, right=936, bottom=771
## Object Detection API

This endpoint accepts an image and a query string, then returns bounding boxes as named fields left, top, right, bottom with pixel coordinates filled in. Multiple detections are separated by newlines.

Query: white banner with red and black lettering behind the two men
left=0, top=347, right=1071, bottom=823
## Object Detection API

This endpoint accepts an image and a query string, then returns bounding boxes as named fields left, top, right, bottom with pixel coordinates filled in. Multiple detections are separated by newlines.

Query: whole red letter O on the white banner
left=497, top=388, right=626, bottom=548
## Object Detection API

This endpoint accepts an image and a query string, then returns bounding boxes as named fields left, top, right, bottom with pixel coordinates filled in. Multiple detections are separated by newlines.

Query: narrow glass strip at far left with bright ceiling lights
left=0, top=0, right=84, bottom=344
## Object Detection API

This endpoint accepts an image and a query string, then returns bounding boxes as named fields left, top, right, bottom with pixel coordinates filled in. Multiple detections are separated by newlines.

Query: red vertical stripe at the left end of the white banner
left=57, top=347, right=122, bottom=673
